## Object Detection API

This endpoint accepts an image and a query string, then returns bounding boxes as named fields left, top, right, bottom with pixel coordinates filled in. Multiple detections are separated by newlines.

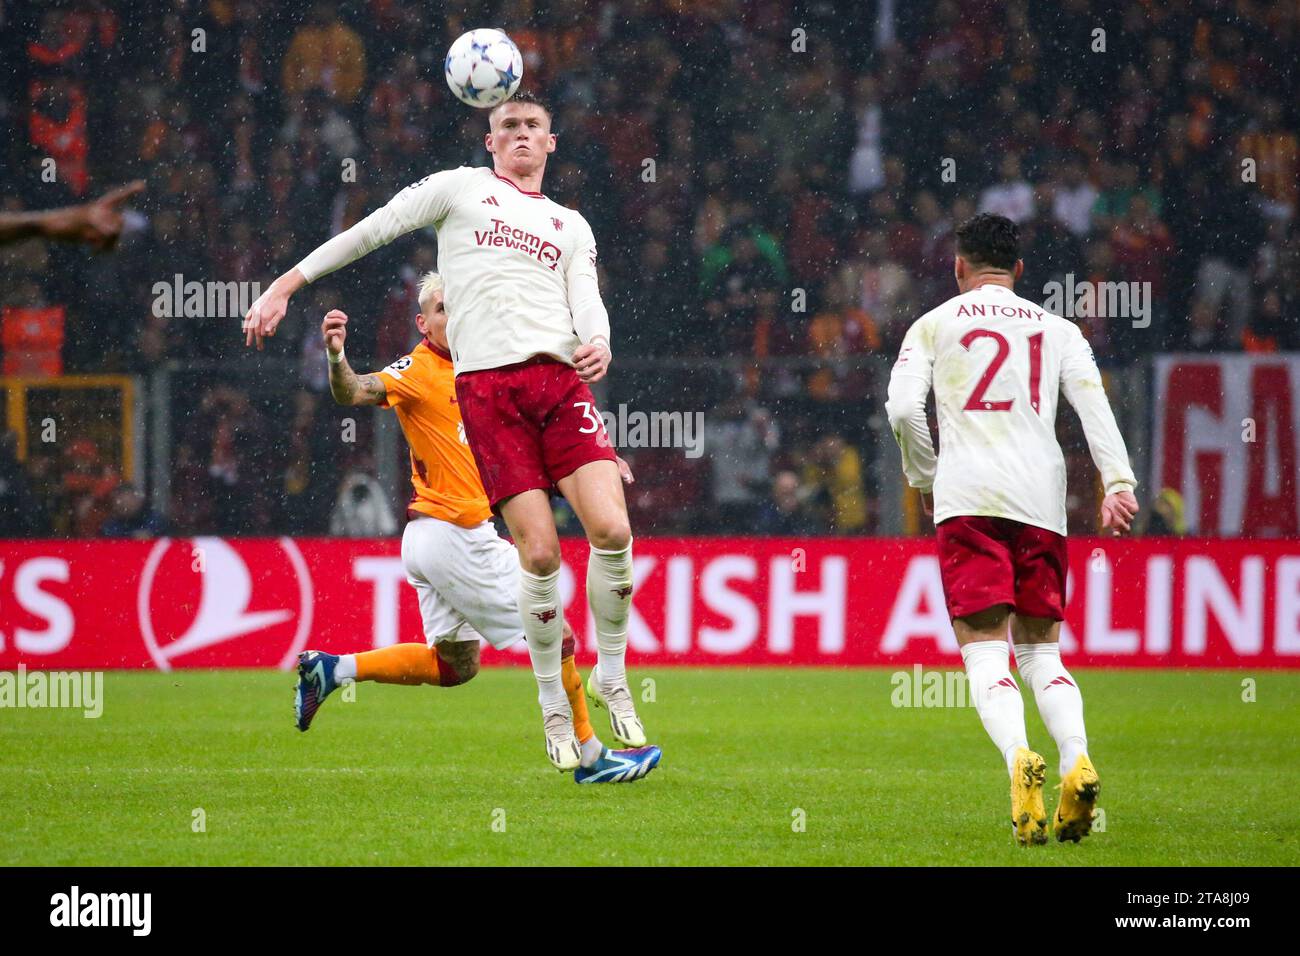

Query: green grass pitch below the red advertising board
left=0, top=669, right=1300, bottom=866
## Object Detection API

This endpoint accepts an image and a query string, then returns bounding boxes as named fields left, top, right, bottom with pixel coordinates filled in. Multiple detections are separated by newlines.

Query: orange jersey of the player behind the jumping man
left=378, top=341, right=491, bottom=528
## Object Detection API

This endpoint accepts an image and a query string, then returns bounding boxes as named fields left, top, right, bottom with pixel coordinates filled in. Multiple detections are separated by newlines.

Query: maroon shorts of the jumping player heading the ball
left=456, top=356, right=618, bottom=507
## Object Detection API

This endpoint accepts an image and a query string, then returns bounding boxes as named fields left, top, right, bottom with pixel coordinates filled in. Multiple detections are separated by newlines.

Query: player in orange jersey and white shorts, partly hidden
left=294, top=273, right=660, bottom=783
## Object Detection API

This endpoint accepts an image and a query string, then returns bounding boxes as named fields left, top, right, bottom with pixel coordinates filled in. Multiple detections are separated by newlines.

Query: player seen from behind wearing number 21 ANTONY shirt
left=887, top=215, right=1138, bottom=845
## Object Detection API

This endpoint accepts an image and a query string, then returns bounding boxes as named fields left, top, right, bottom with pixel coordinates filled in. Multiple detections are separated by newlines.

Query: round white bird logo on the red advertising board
left=137, top=537, right=313, bottom=671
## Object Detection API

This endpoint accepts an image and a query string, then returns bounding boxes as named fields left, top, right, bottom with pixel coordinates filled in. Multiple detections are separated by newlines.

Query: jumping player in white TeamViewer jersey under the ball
left=244, top=92, right=646, bottom=770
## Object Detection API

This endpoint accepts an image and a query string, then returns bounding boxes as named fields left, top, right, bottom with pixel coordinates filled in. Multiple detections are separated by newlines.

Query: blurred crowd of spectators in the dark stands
left=0, top=0, right=1300, bottom=535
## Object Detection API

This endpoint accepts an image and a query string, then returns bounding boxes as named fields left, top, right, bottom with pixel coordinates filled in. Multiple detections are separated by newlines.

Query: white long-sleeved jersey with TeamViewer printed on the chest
left=298, top=166, right=610, bottom=375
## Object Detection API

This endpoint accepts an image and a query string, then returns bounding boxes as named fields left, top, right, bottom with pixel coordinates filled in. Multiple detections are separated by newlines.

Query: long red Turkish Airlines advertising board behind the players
left=0, top=537, right=1300, bottom=670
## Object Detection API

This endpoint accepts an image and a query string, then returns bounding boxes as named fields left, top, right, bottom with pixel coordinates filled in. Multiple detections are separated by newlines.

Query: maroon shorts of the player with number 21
left=936, top=515, right=1066, bottom=620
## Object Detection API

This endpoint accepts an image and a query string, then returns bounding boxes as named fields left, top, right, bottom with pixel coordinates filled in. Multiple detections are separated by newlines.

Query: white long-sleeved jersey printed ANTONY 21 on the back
left=887, top=285, right=1138, bottom=535
